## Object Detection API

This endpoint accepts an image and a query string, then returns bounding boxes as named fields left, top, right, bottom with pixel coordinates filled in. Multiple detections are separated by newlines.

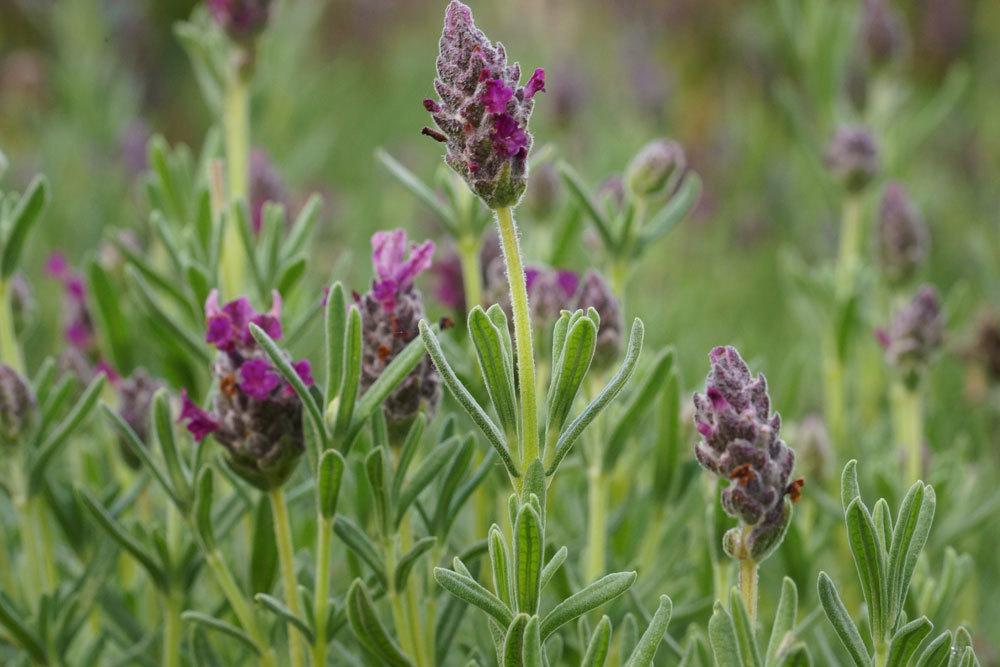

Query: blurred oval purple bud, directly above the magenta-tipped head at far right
left=877, top=183, right=929, bottom=284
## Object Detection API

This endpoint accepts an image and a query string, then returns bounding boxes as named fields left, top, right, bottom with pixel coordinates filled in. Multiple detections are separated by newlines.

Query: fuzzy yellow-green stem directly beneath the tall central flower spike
left=496, top=207, right=539, bottom=478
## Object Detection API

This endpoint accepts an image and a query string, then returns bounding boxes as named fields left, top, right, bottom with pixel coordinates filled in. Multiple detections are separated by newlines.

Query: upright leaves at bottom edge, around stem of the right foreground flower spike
left=708, top=577, right=813, bottom=667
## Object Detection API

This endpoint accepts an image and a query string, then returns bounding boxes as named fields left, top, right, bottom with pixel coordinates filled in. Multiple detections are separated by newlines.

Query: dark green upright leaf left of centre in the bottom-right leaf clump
left=846, top=498, right=888, bottom=642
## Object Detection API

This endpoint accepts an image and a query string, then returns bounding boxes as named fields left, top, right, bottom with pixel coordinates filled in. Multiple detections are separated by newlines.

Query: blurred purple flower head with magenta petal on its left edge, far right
left=875, top=285, right=944, bottom=380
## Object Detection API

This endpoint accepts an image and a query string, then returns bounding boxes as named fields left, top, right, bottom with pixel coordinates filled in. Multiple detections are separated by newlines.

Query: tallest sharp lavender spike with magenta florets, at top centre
left=424, top=0, right=545, bottom=209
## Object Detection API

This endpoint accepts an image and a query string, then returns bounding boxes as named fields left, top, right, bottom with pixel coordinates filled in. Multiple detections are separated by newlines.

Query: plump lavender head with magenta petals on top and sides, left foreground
left=179, top=290, right=313, bottom=490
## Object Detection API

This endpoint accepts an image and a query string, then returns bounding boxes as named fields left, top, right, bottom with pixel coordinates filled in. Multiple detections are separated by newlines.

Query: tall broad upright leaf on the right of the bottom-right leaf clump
left=888, top=482, right=937, bottom=621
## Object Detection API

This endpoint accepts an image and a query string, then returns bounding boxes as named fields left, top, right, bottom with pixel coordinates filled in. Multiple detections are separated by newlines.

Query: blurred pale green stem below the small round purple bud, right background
left=823, top=195, right=861, bottom=448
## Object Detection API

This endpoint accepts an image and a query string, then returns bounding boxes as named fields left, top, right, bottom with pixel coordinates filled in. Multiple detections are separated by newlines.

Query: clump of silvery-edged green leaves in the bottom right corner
left=818, top=461, right=979, bottom=667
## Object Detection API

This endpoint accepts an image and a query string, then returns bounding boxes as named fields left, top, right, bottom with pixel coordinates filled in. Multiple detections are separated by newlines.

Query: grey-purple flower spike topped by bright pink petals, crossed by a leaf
left=355, top=229, right=441, bottom=424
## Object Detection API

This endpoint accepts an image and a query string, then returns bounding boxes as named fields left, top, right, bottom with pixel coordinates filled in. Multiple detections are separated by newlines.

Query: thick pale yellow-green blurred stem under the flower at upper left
left=221, top=67, right=250, bottom=298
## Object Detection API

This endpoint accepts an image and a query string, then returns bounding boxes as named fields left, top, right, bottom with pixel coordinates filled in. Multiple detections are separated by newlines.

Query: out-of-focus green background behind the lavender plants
left=0, top=0, right=1000, bottom=642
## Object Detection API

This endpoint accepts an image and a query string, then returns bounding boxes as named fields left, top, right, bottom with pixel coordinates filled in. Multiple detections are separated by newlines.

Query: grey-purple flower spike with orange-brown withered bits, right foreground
left=694, top=347, right=802, bottom=562
